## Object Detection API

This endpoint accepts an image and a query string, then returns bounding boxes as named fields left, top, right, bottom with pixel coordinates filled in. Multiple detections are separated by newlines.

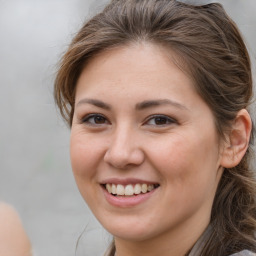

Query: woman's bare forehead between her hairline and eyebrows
left=77, top=43, right=197, bottom=97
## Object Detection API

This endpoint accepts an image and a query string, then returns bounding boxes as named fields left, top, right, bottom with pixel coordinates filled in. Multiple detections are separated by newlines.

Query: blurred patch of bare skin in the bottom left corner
left=0, top=202, right=30, bottom=256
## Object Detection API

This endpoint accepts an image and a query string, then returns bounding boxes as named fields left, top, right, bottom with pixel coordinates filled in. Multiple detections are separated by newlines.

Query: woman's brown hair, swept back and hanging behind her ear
left=55, top=0, right=256, bottom=256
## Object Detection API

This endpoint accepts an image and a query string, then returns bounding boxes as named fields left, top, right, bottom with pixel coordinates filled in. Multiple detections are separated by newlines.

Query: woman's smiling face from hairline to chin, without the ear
left=70, top=44, right=222, bottom=241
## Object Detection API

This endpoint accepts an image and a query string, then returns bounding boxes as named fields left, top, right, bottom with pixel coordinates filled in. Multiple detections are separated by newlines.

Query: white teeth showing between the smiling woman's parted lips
left=103, top=183, right=159, bottom=196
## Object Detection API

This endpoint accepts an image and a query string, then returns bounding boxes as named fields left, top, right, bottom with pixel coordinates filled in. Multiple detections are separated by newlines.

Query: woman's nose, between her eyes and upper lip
left=104, top=125, right=145, bottom=169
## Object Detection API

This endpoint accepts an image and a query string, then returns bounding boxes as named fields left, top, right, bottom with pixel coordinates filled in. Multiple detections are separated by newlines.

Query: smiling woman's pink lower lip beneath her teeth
left=102, top=188, right=158, bottom=208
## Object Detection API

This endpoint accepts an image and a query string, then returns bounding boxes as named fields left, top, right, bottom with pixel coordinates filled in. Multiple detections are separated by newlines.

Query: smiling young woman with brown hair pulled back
left=55, top=0, right=256, bottom=256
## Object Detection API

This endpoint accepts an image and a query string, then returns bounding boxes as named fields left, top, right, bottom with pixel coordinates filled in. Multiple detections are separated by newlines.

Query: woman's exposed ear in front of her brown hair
left=220, top=109, right=252, bottom=168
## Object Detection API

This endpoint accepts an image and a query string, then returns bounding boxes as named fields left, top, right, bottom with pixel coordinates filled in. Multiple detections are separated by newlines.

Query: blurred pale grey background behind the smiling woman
left=0, top=0, right=256, bottom=256
